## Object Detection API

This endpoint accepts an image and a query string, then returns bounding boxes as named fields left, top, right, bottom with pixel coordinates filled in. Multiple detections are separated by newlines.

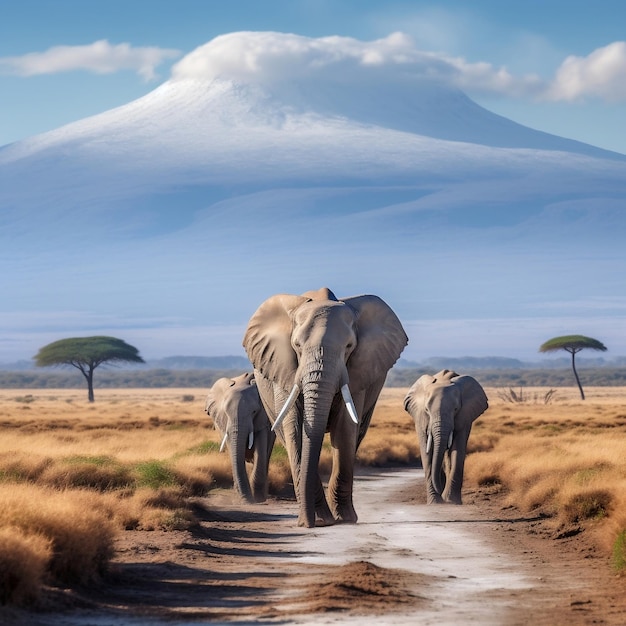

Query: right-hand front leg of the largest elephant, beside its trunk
left=328, top=405, right=358, bottom=524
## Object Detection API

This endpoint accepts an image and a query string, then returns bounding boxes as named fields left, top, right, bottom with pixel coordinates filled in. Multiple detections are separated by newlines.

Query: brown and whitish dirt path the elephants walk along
left=15, top=469, right=626, bottom=626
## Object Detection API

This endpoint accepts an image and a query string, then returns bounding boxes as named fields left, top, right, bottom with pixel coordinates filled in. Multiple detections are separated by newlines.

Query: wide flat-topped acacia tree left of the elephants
left=35, top=336, right=145, bottom=402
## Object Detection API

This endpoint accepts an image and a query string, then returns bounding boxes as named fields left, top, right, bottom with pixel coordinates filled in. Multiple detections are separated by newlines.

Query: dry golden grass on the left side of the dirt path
left=0, top=389, right=290, bottom=603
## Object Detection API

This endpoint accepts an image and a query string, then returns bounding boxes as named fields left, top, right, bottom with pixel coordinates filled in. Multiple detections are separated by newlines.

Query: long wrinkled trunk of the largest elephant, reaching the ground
left=299, top=349, right=347, bottom=528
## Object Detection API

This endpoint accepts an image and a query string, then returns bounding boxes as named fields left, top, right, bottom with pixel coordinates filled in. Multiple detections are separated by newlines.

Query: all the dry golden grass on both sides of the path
left=0, top=388, right=626, bottom=603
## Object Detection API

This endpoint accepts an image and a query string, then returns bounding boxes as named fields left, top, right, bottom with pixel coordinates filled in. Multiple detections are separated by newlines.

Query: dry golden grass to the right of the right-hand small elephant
left=465, top=387, right=626, bottom=569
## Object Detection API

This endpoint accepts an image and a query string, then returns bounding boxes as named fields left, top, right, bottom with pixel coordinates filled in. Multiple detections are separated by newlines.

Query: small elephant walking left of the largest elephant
left=205, top=372, right=276, bottom=503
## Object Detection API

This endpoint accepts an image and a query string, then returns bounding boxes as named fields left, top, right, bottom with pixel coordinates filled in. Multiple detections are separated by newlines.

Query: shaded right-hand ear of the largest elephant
left=342, top=295, right=409, bottom=391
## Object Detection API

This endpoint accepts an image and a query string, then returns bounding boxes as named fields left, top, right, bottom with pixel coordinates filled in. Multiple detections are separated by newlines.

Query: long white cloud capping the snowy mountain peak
left=172, top=32, right=543, bottom=95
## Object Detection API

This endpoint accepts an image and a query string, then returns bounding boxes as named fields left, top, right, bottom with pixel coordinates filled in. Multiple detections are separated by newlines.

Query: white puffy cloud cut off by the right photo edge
left=546, top=41, right=626, bottom=101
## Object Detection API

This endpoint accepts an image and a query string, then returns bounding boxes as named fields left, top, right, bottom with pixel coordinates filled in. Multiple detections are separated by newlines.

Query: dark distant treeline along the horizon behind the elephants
left=0, top=366, right=626, bottom=389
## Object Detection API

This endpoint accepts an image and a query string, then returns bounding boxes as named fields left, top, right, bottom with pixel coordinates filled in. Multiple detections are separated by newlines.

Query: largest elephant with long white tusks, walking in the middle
left=243, top=287, right=408, bottom=528
